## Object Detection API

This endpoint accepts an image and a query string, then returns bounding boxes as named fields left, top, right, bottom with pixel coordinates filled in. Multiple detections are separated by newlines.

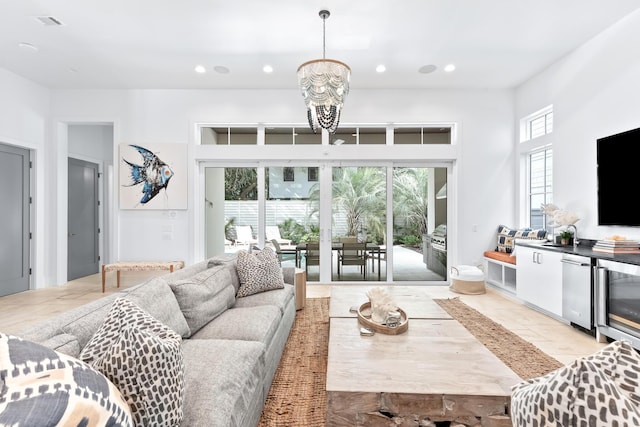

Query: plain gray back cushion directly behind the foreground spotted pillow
left=125, top=277, right=191, bottom=337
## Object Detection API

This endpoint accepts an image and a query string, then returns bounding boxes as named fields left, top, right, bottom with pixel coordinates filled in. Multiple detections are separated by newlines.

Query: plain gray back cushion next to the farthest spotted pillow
left=169, top=265, right=236, bottom=336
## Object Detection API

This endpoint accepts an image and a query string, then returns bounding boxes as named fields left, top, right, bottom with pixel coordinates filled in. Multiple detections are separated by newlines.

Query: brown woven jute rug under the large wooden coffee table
left=258, top=298, right=562, bottom=427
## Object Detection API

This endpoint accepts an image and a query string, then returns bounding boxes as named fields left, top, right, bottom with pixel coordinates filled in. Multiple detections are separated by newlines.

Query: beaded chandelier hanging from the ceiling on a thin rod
left=298, top=10, right=351, bottom=133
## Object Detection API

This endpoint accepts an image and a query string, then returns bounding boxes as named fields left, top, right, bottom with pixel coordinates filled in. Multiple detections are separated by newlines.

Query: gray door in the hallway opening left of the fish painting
left=67, top=158, right=100, bottom=280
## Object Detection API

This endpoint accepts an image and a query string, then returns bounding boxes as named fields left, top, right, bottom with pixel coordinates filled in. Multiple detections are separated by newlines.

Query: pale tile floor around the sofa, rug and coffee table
left=0, top=272, right=605, bottom=363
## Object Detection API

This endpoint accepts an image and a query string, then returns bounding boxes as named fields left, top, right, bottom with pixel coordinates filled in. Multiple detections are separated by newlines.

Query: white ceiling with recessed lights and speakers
left=0, top=0, right=640, bottom=90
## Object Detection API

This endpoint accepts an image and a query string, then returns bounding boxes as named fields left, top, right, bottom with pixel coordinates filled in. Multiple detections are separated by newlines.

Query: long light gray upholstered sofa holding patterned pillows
left=17, top=258, right=296, bottom=427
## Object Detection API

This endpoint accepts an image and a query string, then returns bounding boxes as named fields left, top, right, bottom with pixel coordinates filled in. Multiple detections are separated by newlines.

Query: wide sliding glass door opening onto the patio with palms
left=205, top=161, right=447, bottom=283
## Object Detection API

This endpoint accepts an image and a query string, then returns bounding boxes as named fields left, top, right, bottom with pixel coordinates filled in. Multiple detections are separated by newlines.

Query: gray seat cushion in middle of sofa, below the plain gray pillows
left=191, top=305, right=282, bottom=347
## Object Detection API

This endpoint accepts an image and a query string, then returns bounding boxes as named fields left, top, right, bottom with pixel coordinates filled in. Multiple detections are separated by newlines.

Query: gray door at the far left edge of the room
left=0, top=144, right=30, bottom=296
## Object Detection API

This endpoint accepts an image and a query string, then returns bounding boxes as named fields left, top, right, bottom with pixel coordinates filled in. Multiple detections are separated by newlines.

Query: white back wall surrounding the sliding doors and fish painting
left=52, top=89, right=515, bottom=274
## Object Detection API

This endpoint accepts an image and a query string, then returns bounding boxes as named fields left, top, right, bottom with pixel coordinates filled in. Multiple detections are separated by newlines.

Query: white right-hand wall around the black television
left=516, top=11, right=640, bottom=239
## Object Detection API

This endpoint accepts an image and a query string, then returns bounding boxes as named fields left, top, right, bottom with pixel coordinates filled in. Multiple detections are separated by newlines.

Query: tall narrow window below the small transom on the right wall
left=527, top=147, right=553, bottom=231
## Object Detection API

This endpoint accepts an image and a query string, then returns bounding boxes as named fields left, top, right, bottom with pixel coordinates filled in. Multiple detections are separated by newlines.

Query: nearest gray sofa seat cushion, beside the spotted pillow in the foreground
left=182, top=339, right=265, bottom=427
